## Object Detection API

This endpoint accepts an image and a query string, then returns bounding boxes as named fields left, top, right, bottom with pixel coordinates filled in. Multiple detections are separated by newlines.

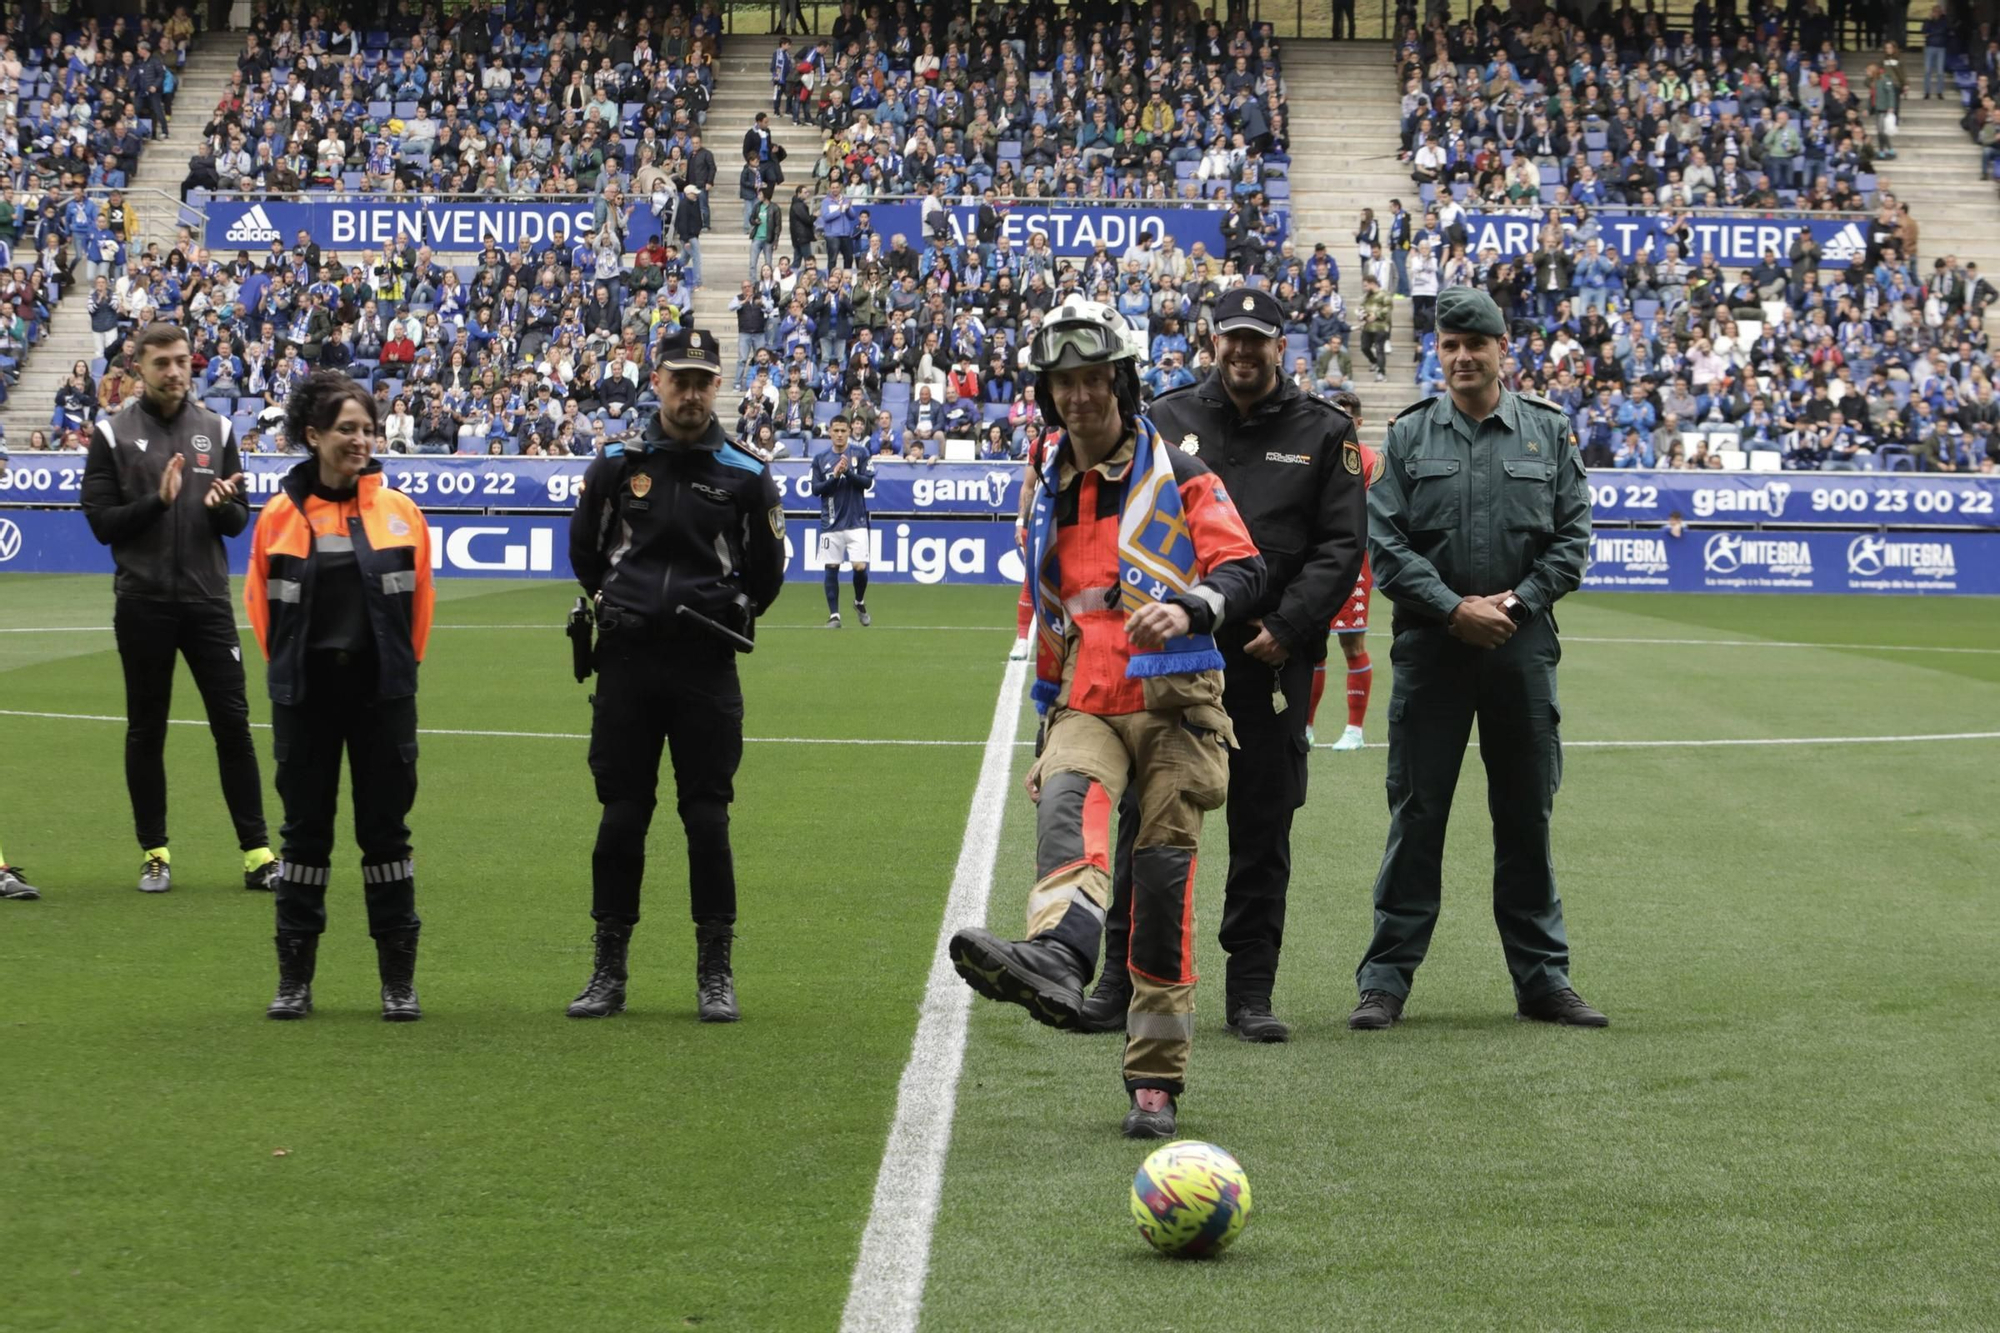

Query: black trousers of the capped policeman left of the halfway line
left=590, top=630, right=744, bottom=925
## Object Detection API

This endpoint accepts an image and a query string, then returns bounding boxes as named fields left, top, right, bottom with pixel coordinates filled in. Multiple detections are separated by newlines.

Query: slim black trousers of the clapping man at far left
left=112, top=596, right=270, bottom=851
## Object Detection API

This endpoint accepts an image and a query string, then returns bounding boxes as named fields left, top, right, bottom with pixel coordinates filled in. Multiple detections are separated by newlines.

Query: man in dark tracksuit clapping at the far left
left=82, top=324, right=276, bottom=893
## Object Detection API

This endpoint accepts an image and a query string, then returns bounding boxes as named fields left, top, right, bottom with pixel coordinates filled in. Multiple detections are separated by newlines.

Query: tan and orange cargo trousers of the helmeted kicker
left=1028, top=707, right=1234, bottom=1097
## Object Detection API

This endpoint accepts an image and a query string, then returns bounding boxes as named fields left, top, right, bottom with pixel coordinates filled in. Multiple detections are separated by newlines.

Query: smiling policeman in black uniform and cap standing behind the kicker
left=1084, top=288, right=1368, bottom=1041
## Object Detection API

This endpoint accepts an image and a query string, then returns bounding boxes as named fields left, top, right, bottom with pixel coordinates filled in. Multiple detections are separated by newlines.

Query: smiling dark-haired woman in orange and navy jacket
left=244, top=370, right=434, bottom=1023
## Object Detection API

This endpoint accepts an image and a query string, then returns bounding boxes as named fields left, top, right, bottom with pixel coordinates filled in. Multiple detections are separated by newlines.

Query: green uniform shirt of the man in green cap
left=1368, top=390, right=1590, bottom=622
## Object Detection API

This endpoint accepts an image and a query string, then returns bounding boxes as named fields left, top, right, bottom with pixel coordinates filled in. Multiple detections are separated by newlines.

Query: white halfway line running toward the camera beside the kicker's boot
left=840, top=662, right=1028, bottom=1333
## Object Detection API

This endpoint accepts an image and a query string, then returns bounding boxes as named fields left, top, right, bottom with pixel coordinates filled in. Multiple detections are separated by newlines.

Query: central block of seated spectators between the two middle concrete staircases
left=730, top=2, right=1304, bottom=460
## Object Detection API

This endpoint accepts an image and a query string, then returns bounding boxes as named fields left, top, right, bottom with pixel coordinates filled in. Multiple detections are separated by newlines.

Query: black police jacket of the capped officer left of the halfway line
left=570, top=412, right=784, bottom=634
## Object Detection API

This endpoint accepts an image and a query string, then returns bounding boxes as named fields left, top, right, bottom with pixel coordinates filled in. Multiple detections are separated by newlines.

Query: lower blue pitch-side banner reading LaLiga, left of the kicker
left=0, top=508, right=1024, bottom=580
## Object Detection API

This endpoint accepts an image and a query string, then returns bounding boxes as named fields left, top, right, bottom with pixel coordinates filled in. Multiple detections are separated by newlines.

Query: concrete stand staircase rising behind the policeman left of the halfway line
left=694, top=34, right=822, bottom=368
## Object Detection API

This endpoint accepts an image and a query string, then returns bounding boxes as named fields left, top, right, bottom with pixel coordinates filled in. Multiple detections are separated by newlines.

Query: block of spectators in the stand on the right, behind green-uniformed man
left=1240, top=0, right=2000, bottom=472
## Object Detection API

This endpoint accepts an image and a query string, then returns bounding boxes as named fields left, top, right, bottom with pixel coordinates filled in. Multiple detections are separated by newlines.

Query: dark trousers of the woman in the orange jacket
left=270, top=654, right=422, bottom=937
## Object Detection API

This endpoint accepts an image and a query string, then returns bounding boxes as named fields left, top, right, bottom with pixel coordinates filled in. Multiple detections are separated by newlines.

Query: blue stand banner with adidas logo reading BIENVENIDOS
left=204, top=198, right=616, bottom=254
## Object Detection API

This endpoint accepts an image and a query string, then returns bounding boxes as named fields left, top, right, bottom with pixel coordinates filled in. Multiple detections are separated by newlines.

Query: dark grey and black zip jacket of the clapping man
left=82, top=394, right=250, bottom=600
